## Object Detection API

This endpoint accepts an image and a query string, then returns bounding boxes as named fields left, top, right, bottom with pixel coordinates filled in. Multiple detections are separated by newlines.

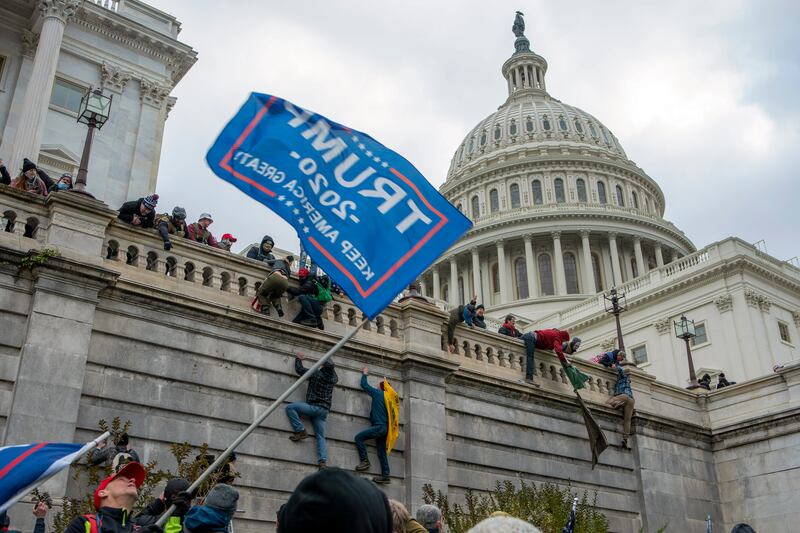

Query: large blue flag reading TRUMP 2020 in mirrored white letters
left=206, top=93, right=472, bottom=318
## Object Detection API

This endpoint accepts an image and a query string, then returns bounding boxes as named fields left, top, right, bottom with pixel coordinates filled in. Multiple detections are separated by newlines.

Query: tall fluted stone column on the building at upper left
left=8, top=0, right=82, bottom=169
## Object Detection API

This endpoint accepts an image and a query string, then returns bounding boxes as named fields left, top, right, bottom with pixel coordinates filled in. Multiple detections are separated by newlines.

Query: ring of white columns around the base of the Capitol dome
left=421, top=230, right=681, bottom=306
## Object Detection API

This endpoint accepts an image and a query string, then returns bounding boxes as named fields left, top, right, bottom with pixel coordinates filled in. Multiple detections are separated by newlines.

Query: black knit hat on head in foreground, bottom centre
left=278, top=468, right=392, bottom=533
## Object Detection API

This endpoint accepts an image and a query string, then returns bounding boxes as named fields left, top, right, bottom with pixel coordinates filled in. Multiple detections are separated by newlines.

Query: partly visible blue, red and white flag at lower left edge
left=0, top=442, right=95, bottom=513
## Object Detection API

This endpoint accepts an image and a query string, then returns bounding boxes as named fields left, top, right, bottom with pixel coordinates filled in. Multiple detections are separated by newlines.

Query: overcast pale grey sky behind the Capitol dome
left=148, top=0, right=800, bottom=259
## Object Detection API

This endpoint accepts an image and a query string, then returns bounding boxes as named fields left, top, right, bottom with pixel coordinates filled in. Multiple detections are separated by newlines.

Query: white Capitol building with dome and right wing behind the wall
left=421, top=14, right=800, bottom=385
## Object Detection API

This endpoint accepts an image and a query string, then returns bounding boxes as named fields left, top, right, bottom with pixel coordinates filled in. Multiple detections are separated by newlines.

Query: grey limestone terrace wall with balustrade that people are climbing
left=0, top=187, right=800, bottom=532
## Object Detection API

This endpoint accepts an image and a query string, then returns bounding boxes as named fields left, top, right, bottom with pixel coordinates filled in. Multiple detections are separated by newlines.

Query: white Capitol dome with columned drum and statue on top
left=421, top=14, right=695, bottom=320
